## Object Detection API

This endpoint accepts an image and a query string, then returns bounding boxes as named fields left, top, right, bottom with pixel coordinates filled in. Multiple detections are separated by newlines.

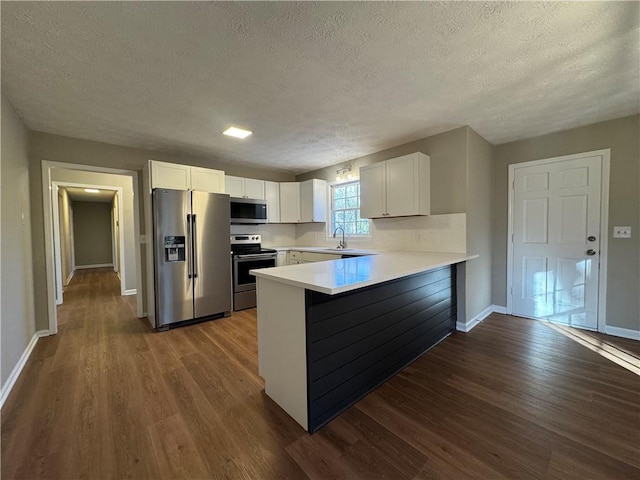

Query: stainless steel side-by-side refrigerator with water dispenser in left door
left=153, top=188, right=232, bottom=329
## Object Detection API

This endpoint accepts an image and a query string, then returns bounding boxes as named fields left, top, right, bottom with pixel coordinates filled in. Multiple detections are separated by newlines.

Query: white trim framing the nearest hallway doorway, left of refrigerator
left=42, top=160, right=144, bottom=335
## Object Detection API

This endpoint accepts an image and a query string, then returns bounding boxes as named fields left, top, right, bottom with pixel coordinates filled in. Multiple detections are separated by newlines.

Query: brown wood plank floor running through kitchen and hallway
left=2, top=270, right=640, bottom=479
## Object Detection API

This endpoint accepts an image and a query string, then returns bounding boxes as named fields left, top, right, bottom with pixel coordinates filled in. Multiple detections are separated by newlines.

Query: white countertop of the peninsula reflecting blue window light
left=249, top=251, right=478, bottom=295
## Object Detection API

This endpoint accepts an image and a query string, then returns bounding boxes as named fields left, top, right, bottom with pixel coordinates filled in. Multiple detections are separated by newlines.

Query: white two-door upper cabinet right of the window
left=360, top=152, right=431, bottom=218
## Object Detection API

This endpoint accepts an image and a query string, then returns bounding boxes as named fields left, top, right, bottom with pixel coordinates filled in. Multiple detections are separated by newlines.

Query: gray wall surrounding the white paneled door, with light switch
left=492, top=115, right=640, bottom=330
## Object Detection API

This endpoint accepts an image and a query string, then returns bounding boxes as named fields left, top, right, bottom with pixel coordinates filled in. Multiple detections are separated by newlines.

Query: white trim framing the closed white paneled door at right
left=507, top=148, right=611, bottom=332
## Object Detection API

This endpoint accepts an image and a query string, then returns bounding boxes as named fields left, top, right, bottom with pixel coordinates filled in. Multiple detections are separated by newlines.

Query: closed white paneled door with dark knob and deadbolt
left=511, top=154, right=602, bottom=330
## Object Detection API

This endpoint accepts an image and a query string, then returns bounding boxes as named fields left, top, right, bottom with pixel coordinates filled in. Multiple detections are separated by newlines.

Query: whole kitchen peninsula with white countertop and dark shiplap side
left=251, top=252, right=478, bottom=433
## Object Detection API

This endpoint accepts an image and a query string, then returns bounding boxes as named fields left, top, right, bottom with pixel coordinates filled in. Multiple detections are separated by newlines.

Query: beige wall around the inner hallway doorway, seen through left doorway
left=51, top=168, right=136, bottom=290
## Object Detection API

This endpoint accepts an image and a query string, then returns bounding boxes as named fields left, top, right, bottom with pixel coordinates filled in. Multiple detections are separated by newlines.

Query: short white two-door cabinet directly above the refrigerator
left=149, top=160, right=225, bottom=193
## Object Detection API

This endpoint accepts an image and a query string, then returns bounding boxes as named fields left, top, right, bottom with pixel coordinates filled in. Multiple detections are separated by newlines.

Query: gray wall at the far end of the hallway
left=73, top=202, right=113, bottom=267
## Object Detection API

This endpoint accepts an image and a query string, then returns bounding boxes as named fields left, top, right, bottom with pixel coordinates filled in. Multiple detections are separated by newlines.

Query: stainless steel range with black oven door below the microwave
left=231, top=234, right=278, bottom=311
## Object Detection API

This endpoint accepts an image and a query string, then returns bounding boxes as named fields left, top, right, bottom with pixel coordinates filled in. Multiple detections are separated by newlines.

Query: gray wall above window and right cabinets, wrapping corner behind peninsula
left=296, top=127, right=492, bottom=321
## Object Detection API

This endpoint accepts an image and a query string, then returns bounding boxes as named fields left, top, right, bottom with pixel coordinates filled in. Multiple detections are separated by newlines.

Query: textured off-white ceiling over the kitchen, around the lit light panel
left=1, top=2, right=640, bottom=173
